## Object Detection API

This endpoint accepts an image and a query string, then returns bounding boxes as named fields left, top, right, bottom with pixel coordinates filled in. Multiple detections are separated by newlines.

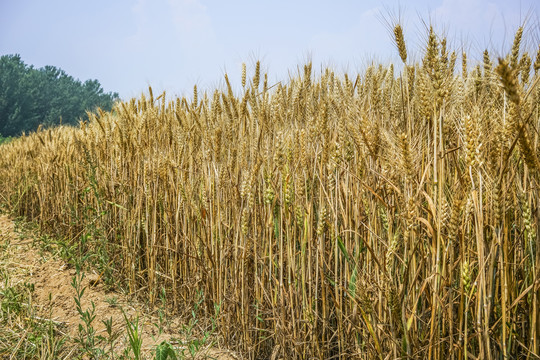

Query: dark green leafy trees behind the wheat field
left=0, top=55, right=118, bottom=138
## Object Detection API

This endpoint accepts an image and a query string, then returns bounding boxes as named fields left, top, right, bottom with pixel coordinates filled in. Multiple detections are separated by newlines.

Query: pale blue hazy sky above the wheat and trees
left=0, top=0, right=540, bottom=100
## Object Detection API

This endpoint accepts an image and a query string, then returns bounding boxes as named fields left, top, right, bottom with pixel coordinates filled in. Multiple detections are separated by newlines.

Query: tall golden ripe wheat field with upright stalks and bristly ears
left=0, top=25, right=540, bottom=359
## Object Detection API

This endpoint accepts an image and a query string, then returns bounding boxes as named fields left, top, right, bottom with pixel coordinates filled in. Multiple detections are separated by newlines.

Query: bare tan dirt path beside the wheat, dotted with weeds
left=0, top=215, right=239, bottom=359
